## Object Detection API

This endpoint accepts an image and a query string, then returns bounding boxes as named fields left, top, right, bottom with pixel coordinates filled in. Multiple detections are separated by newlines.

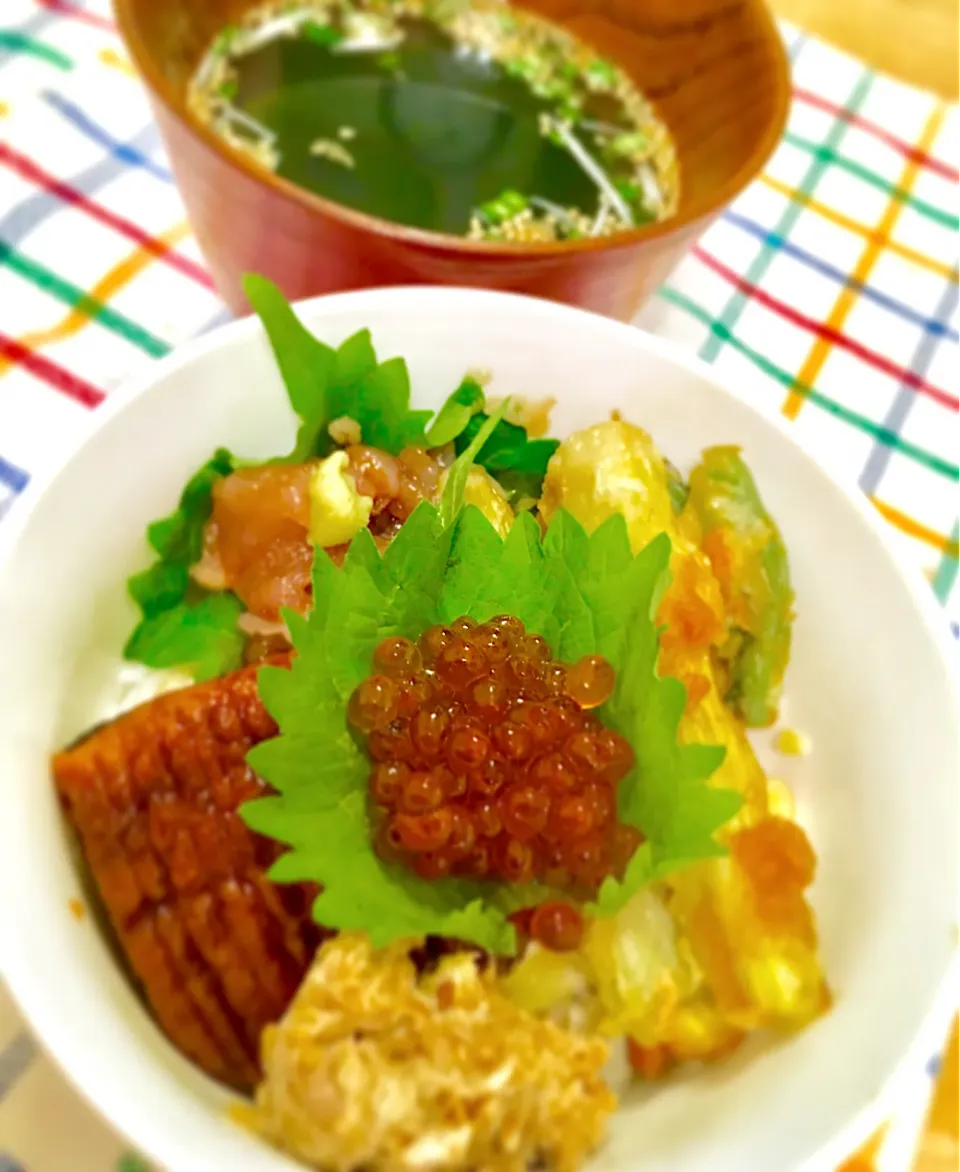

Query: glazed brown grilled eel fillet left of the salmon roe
left=53, top=668, right=321, bottom=1090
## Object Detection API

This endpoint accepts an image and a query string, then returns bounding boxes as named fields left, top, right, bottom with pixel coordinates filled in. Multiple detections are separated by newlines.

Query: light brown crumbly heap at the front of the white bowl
left=236, top=935, right=617, bottom=1172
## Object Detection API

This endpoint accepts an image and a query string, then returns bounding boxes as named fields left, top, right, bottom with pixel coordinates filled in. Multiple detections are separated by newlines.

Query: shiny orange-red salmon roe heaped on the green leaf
left=348, top=615, right=641, bottom=909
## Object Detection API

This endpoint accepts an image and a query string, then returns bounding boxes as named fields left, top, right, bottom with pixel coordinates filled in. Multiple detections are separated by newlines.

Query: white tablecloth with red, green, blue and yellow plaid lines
left=0, top=0, right=960, bottom=1172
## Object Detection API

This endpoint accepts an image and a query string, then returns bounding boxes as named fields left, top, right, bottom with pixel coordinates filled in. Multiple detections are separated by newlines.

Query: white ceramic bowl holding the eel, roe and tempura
left=0, top=288, right=960, bottom=1172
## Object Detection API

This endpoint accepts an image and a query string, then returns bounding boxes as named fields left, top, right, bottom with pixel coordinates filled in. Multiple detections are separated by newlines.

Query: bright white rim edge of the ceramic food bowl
left=0, top=285, right=960, bottom=1172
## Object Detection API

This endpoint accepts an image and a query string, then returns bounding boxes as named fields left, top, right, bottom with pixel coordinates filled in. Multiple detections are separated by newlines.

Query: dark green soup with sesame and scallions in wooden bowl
left=190, top=0, right=676, bottom=241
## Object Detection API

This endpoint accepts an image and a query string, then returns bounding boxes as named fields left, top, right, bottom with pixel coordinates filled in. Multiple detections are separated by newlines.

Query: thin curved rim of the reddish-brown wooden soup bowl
left=114, top=0, right=790, bottom=259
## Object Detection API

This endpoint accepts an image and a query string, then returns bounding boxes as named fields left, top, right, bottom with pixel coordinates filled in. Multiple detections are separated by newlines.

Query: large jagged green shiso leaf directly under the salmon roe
left=241, top=501, right=741, bottom=954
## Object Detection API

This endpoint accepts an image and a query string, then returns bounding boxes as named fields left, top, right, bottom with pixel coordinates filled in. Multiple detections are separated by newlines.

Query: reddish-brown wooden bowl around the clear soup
left=115, top=0, right=790, bottom=320
